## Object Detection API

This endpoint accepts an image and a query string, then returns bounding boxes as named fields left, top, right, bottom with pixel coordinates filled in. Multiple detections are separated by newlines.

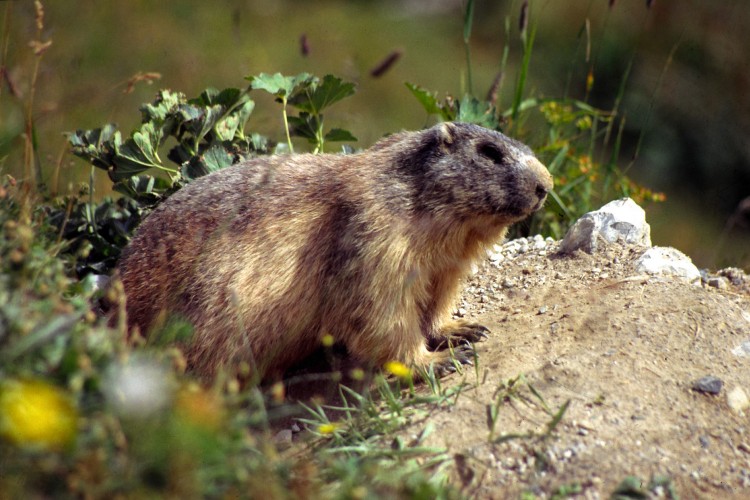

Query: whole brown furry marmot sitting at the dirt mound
left=118, top=123, right=552, bottom=380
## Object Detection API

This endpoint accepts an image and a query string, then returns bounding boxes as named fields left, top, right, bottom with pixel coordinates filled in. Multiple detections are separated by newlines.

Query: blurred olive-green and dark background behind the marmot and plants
left=0, top=0, right=750, bottom=269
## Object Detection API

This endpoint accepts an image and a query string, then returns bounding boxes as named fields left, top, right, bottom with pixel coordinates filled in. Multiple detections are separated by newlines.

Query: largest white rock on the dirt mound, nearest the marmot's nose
left=560, top=198, right=651, bottom=253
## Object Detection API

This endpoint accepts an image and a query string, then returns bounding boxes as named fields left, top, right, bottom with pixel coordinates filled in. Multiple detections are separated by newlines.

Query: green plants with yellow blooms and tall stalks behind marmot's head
left=406, top=2, right=664, bottom=238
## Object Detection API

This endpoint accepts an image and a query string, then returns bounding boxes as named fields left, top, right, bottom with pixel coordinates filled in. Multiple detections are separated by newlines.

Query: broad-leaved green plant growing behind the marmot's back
left=60, top=73, right=356, bottom=275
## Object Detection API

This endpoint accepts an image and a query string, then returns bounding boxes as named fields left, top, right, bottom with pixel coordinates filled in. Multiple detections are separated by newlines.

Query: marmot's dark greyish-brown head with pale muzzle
left=399, top=122, right=552, bottom=223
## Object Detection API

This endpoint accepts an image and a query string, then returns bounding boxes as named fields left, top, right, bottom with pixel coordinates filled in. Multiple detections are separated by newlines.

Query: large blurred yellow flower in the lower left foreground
left=0, top=380, right=78, bottom=449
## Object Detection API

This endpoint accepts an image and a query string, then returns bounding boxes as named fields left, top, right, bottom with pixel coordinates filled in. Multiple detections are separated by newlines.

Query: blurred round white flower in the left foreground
left=105, top=357, right=176, bottom=417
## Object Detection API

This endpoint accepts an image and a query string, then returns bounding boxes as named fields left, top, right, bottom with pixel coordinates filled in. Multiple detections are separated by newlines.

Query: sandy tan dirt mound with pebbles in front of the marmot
left=418, top=237, right=750, bottom=498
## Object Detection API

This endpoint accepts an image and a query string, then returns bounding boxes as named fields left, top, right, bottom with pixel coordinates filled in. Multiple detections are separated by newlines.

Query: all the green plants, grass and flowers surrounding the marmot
left=0, top=1, right=659, bottom=498
